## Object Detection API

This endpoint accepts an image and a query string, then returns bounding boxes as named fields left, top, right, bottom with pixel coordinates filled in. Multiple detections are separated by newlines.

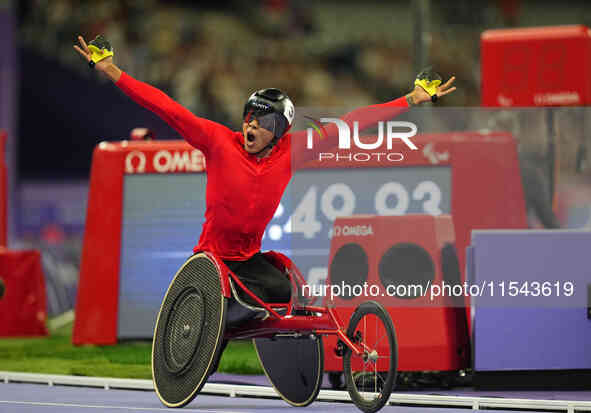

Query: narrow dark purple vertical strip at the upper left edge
left=0, top=2, right=18, bottom=246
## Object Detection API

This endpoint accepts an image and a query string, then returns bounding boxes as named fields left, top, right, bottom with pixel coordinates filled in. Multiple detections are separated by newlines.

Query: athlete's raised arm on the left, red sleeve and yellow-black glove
left=74, top=36, right=231, bottom=156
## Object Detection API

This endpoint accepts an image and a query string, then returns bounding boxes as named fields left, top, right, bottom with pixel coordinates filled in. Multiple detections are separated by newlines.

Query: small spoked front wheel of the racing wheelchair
left=343, top=301, right=398, bottom=413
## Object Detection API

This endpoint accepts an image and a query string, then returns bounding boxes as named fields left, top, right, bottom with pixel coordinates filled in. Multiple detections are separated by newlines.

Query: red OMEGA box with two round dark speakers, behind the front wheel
left=325, top=215, right=469, bottom=371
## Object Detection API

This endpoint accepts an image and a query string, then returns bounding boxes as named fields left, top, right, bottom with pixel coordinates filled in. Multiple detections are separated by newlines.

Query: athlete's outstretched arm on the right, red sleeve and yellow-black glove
left=291, top=76, right=456, bottom=168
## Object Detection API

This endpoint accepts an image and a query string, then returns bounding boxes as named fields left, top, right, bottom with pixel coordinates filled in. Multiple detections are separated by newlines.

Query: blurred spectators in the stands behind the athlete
left=19, top=0, right=519, bottom=128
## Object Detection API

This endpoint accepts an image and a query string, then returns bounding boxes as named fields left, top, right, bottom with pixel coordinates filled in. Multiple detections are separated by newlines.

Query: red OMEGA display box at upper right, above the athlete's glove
left=480, top=25, right=591, bottom=107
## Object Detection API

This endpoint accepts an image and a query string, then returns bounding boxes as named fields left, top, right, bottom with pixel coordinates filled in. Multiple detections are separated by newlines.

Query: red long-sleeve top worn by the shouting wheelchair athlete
left=116, top=72, right=408, bottom=261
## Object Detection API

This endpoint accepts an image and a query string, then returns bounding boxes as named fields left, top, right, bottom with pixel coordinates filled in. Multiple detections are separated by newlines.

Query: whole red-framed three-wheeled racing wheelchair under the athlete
left=152, top=251, right=398, bottom=413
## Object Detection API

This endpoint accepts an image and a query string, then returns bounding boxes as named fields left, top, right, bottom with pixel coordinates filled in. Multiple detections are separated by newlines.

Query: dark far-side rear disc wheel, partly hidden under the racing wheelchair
left=252, top=336, right=324, bottom=407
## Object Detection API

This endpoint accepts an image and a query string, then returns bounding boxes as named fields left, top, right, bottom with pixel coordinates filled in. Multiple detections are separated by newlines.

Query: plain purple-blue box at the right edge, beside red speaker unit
left=467, top=230, right=591, bottom=371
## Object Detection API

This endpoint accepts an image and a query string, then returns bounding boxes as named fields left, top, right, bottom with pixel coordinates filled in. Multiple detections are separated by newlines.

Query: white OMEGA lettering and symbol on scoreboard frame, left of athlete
left=125, top=149, right=205, bottom=174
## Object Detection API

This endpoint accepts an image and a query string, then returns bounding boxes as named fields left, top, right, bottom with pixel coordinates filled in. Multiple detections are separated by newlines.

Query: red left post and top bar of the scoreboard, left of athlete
left=72, top=141, right=203, bottom=345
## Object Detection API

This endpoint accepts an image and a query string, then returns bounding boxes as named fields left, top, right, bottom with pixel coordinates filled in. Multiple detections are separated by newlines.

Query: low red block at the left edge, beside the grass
left=0, top=248, right=47, bottom=337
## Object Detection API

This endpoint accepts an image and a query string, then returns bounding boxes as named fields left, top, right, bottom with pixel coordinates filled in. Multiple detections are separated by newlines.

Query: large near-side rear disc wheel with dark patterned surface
left=152, top=254, right=227, bottom=407
